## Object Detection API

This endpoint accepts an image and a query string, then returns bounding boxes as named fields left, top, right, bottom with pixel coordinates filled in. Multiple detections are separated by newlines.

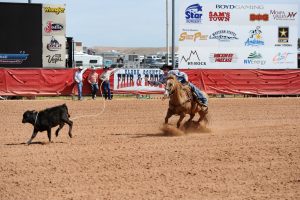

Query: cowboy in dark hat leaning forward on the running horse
left=148, top=64, right=208, bottom=108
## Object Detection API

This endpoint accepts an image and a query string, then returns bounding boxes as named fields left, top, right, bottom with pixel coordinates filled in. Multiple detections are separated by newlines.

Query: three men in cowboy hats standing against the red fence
left=74, top=66, right=116, bottom=100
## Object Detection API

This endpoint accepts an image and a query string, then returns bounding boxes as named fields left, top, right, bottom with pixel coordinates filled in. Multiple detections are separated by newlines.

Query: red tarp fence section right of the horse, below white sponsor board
left=184, top=69, right=300, bottom=95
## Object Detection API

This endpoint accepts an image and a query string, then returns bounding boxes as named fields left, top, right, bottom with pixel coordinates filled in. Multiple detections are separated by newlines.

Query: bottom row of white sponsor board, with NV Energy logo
left=178, top=47, right=297, bottom=69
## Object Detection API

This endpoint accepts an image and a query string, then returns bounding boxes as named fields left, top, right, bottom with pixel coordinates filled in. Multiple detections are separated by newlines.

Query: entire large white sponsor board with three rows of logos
left=178, top=0, right=299, bottom=69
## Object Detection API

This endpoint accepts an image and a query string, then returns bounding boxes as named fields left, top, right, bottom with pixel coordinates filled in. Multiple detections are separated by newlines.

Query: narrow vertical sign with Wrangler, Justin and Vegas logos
left=42, top=4, right=66, bottom=68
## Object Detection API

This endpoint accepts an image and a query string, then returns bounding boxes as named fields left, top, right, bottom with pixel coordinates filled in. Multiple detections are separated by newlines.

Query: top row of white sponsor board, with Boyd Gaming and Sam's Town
left=179, top=0, right=299, bottom=26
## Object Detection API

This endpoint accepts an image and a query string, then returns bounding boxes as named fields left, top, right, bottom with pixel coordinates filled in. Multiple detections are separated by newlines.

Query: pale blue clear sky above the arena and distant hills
left=0, top=0, right=300, bottom=47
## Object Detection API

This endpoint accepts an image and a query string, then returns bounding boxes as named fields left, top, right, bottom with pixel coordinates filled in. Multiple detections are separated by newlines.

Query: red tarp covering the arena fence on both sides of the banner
left=0, top=69, right=300, bottom=96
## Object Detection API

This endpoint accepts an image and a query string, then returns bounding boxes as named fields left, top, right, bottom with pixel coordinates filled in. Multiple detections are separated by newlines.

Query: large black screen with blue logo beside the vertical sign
left=0, top=3, right=42, bottom=68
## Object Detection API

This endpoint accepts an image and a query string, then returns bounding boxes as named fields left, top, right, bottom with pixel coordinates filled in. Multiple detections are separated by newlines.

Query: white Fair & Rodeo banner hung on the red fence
left=114, top=69, right=164, bottom=92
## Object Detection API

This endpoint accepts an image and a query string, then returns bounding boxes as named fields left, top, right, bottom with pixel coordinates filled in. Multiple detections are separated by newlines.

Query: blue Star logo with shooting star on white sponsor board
left=185, top=4, right=203, bottom=24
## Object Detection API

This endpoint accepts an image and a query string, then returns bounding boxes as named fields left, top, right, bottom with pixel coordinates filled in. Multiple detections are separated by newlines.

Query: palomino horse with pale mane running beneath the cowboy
left=165, top=75, right=208, bottom=128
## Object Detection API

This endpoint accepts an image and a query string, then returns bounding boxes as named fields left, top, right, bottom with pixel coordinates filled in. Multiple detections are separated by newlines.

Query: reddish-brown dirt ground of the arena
left=0, top=98, right=300, bottom=200
